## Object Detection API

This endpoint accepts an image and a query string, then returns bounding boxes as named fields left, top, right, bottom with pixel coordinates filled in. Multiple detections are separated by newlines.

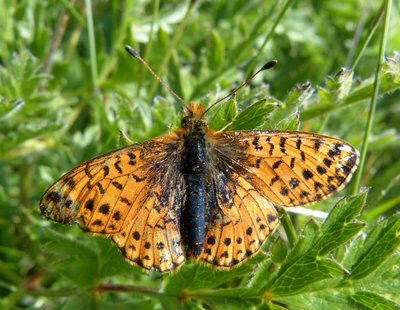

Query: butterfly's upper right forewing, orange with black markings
left=210, top=131, right=358, bottom=206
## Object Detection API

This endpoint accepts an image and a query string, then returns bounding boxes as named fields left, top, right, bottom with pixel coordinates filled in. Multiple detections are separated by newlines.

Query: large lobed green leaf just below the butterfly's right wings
left=253, top=193, right=366, bottom=296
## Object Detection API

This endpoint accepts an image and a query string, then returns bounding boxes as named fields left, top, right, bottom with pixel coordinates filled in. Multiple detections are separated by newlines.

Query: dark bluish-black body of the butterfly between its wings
left=182, top=135, right=207, bottom=257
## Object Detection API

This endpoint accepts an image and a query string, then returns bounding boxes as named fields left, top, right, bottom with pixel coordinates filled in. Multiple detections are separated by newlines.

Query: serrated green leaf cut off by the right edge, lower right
left=349, top=215, right=400, bottom=280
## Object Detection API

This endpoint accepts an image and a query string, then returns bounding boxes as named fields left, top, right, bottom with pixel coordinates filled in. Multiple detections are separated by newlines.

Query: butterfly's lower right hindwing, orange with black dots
left=201, top=168, right=278, bottom=268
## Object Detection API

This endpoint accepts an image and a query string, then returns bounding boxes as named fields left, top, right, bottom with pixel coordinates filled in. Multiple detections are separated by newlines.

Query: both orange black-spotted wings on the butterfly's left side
left=40, top=133, right=185, bottom=271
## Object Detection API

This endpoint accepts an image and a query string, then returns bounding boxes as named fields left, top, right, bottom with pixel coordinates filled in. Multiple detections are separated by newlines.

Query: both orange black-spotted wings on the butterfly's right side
left=201, top=131, right=358, bottom=267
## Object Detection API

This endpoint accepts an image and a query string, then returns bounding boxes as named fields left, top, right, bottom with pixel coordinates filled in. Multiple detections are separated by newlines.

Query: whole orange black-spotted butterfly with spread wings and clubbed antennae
left=40, top=47, right=358, bottom=272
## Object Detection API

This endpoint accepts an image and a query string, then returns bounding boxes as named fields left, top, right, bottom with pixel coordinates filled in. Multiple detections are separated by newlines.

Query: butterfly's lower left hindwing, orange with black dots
left=112, top=173, right=185, bottom=272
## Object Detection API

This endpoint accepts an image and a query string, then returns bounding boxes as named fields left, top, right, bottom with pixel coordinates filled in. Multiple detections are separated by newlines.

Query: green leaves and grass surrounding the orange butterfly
left=0, top=0, right=400, bottom=309
